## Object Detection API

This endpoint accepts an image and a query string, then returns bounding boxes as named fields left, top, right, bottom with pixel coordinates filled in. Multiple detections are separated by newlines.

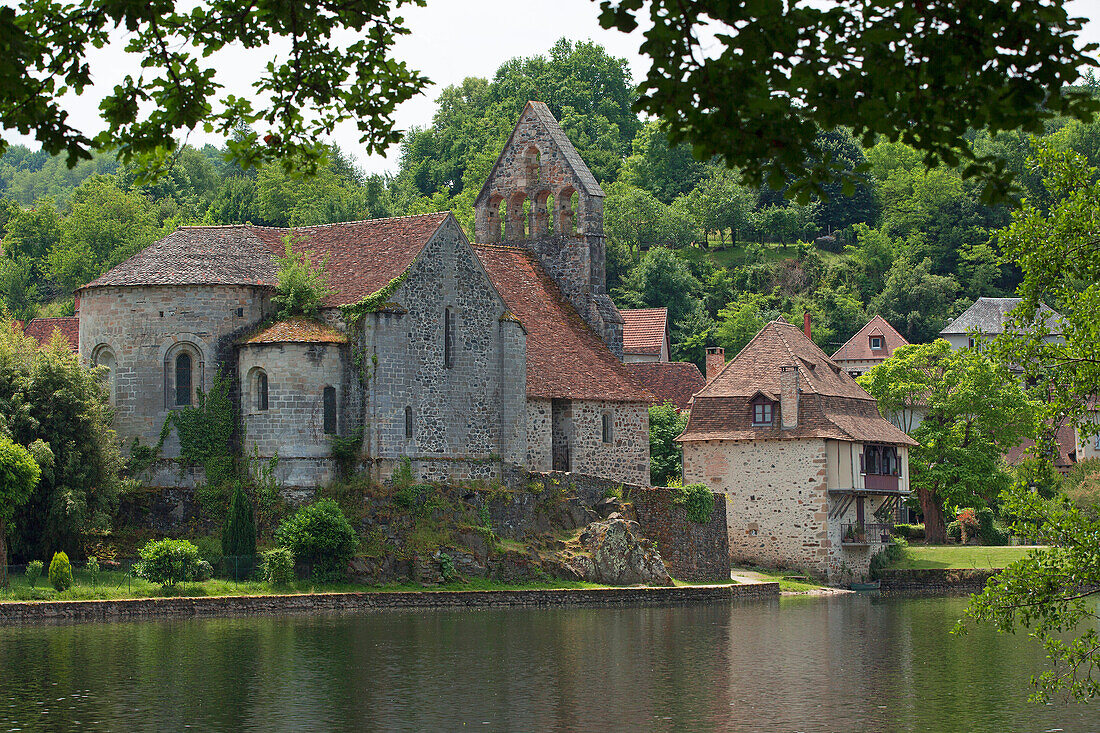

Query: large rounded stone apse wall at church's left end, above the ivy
left=79, top=285, right=270, bottom=458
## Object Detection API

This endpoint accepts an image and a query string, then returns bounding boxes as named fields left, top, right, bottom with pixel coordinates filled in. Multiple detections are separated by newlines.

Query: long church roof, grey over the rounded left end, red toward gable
left=84, top=211, right=451, bottom=306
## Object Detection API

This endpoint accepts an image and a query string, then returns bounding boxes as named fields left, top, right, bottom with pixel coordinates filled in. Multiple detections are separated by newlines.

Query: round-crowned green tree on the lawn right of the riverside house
left=858, top=339, right=1036, bottom=544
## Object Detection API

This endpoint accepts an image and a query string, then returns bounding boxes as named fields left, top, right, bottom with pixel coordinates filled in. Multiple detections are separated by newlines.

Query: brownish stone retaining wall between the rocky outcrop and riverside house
left=629, top=489, right=729, bottom=581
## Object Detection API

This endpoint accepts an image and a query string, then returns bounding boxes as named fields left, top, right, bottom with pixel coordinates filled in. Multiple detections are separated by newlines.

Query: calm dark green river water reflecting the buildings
left=0, top=595, right=1100, bottom=733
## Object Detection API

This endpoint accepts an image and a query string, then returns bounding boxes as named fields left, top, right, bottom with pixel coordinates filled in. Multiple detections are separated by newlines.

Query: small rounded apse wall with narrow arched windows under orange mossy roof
left=238, top=343, right=349, bottom=488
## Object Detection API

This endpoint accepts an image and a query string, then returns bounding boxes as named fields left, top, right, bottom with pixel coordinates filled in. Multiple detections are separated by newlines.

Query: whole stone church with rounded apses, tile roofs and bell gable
left=76, top=102, right=653, bottom=488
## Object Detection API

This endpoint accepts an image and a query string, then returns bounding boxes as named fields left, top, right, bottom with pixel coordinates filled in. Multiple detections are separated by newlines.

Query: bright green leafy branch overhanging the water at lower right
left=956, top=484, right=1100, bottom=702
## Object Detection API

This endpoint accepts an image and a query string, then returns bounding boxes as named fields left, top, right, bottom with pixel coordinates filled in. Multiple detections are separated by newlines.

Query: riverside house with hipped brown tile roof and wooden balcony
left=678, top=320, right=916, bottom=582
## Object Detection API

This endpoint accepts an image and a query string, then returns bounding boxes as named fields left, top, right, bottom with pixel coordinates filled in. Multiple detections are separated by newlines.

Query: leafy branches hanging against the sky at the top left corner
left=0, top=0, right=428, bottom=168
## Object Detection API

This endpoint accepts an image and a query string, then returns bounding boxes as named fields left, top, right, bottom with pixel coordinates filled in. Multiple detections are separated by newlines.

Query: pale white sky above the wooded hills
left=8, top=0, right=1100, bottom=173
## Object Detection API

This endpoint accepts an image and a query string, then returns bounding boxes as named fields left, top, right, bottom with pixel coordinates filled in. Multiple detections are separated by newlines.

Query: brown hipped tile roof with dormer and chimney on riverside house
left=678, top=320, right=916, bottom=446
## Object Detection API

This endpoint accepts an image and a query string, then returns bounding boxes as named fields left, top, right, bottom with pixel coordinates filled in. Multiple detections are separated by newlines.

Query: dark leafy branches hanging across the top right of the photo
left=600, top=0, right=1100, bottom=198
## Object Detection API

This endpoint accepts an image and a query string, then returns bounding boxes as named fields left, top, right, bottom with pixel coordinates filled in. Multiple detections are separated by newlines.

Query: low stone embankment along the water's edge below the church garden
left=0, top=583, right=780, bottom=626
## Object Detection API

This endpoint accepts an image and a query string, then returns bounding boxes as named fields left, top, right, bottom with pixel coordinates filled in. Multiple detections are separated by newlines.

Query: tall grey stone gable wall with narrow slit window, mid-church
left=352, top=216, right=527, bottom=478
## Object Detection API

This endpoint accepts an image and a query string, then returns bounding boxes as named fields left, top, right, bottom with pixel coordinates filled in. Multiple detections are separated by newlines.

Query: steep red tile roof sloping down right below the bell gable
left=474, top=244, right=653, bottom=403
